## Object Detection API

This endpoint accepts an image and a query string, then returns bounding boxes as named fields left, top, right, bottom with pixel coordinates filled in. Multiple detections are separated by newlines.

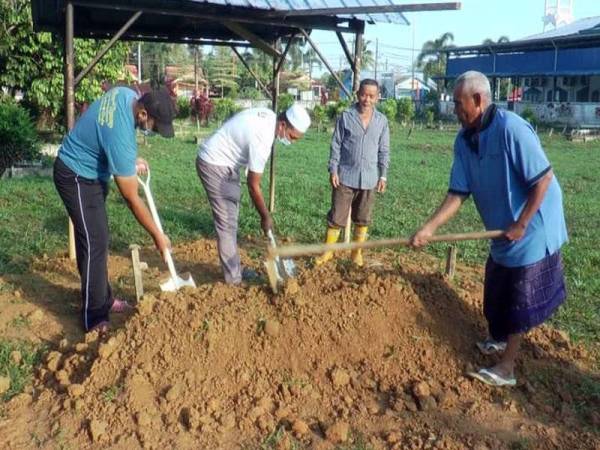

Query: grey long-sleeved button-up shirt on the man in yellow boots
left=329, top=105, right=390, bottom=190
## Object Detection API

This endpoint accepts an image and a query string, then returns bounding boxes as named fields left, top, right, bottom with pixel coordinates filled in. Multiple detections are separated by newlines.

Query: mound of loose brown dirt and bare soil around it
left=0, top=240, right=600, bottom=450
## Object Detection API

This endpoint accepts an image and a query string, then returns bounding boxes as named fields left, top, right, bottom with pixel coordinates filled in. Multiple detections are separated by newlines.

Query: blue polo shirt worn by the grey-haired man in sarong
left=449, top=109, right=567, bottom=267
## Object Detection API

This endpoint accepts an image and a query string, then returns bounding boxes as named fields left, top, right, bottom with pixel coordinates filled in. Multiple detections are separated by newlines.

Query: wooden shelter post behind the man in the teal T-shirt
left=64, top=2, right=76, bottom=259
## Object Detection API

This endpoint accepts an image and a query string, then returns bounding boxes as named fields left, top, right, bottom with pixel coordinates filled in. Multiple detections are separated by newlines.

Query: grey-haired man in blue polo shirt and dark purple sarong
left=411, top=71, right=567, bottom=386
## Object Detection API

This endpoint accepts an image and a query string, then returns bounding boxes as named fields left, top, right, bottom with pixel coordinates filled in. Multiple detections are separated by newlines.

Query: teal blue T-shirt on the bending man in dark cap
left=58, top=87, right=137, bottom=181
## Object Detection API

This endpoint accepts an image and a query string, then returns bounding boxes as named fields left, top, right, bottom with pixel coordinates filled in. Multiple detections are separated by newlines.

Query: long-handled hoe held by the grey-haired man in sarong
left=265, top=230, right=504, bottom=293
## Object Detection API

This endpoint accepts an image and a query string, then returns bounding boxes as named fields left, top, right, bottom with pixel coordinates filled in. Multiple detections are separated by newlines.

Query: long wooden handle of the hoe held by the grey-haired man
left=268, top=230, right=504, bottom=258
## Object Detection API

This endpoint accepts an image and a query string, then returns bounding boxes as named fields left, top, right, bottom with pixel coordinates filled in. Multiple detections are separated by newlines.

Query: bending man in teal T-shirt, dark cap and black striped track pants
left=54, top=87, right=175, bottom=332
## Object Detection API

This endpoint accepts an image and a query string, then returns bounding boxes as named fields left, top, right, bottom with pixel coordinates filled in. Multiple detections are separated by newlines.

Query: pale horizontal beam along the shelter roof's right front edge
left=266, top=2, right=462, bottom=17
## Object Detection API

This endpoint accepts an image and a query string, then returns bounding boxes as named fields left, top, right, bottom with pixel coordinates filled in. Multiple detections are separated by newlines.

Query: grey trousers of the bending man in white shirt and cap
left=196, top=157, right=242, bottom=284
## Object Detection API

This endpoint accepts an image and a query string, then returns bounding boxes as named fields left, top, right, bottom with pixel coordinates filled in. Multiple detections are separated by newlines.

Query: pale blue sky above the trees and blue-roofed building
left=312, top=0, right=600, bottom=76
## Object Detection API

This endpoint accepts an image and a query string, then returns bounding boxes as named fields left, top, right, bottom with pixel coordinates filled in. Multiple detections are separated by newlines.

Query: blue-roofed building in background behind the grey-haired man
left=441, top=16, right=600, bottom=127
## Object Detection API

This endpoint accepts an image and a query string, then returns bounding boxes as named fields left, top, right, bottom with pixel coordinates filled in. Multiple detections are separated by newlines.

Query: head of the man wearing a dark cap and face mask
left=135, top=90, right=175, bottom=137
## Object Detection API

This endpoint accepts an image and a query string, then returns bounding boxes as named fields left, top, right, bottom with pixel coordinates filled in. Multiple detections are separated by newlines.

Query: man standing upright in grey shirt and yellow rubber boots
left=315, top=79, right=390, bottom=267
